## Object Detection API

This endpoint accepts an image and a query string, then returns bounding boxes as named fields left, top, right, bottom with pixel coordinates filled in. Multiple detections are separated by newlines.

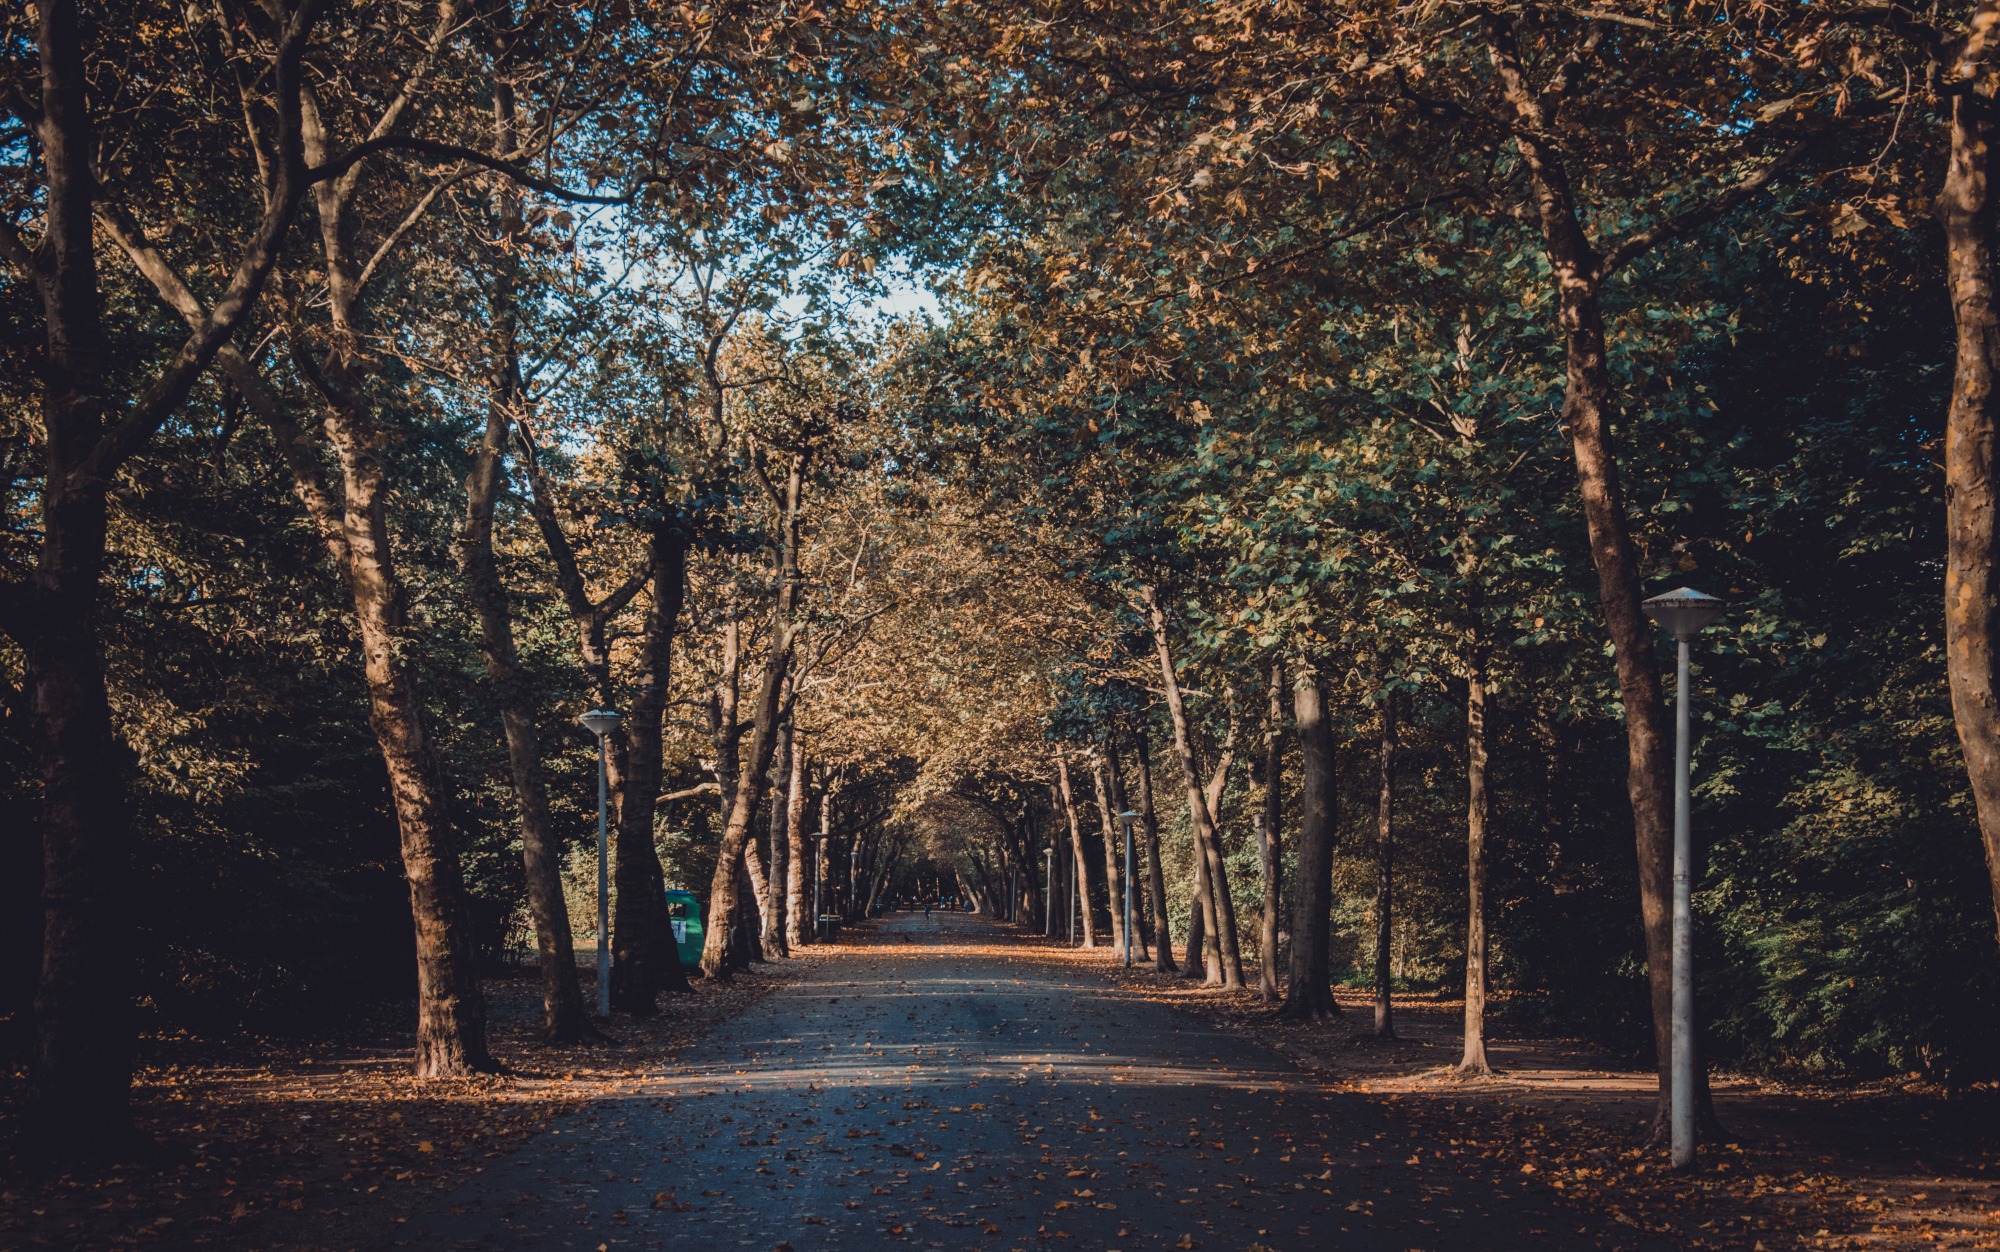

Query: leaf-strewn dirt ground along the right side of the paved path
left=1058, top=932, right=2000, bottom=1252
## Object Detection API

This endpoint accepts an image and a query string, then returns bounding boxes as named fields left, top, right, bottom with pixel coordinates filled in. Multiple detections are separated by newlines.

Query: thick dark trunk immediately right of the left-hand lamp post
left=612, top=522, right=692, bottom=1016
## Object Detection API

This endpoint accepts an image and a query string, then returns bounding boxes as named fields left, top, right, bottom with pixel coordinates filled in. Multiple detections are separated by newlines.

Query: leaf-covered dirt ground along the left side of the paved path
left=0, top=948, right=826, bottom=1252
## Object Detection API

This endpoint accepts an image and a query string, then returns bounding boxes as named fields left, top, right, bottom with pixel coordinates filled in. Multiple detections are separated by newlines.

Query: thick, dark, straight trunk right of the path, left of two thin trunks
left=1278, top=674, right=1340, bottom=1022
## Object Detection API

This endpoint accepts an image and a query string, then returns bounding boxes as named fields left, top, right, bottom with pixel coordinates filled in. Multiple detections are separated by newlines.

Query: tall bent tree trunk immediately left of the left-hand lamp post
left=458, top=63, right=602, bottom=1044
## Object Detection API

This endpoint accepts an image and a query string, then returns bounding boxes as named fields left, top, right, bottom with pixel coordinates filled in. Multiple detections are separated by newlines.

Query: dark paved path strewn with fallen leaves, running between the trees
left=386, top=914, right=1642, bottom=1252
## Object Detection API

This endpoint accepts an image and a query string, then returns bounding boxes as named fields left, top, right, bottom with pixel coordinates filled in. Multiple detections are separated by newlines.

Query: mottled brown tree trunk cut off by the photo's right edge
left=1938, top=24, right=2000, bottom=932
